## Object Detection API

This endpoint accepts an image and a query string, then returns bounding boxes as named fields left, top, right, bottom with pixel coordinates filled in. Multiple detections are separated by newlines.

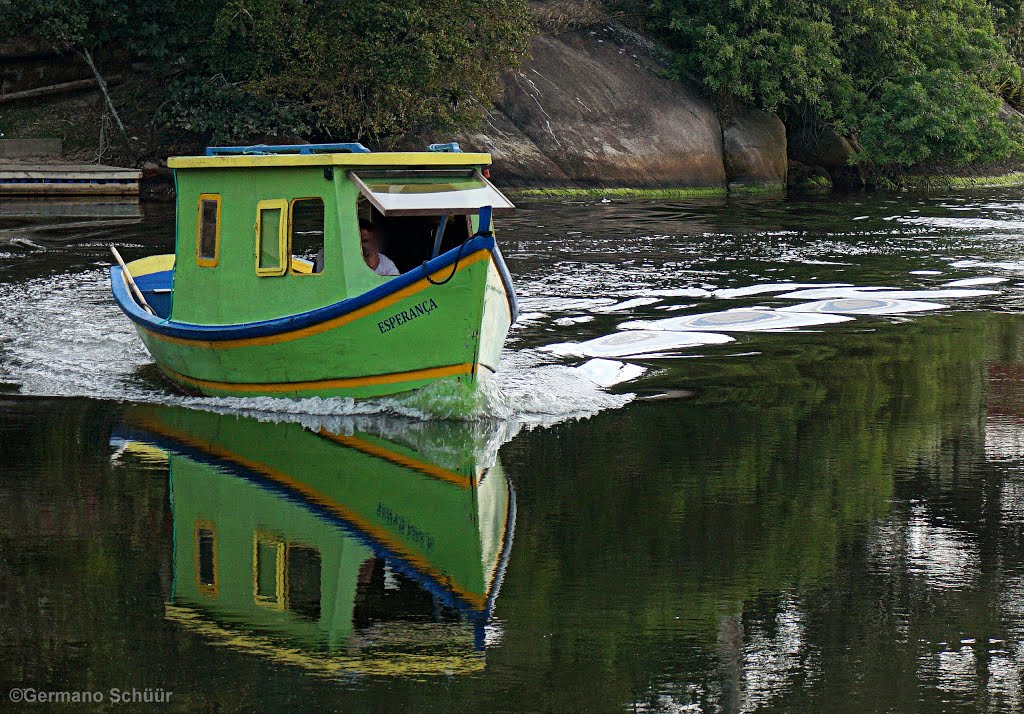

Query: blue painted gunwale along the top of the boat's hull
left=110, top=236, right=519, bottom=342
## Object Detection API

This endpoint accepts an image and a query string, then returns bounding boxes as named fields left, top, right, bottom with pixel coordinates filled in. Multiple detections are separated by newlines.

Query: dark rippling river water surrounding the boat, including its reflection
left=0, top=193, right=1024, bottom=712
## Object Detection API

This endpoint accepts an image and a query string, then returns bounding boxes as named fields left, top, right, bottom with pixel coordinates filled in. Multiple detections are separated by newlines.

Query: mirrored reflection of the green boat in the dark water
left=116, top=408, right=515, bottom=676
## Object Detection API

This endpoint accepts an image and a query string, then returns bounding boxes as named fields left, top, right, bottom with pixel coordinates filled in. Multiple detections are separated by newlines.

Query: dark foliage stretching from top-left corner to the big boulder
left=0, top=0, right=531, bottom=146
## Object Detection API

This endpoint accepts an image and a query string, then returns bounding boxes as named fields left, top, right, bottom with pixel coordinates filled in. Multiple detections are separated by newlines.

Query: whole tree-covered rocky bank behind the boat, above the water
left=6, top=0, right=1024, bottom=194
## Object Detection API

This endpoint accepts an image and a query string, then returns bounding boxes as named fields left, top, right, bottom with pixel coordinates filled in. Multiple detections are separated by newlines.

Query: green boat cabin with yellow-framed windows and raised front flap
left=162, top=143, right=514, bottom=325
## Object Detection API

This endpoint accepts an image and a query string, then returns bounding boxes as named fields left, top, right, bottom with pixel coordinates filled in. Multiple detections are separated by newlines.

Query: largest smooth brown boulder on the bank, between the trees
left=464, top=23, right=726, bottom=188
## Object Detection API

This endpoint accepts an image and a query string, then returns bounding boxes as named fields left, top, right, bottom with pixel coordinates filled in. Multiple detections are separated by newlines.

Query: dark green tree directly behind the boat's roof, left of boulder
left=167, top=0, right=531, bottom=146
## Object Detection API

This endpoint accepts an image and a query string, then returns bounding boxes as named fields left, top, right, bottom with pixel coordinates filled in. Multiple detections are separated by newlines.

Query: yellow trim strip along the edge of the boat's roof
left=167, top=152, right=490, bottom=169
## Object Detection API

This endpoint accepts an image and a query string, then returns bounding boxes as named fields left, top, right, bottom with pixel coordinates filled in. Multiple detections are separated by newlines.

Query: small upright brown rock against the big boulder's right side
left=722, top=111, right=787, bottom=191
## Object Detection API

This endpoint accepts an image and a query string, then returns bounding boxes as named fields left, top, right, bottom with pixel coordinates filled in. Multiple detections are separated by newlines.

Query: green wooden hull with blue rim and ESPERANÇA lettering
left=112, top=239, right=516, bottom=397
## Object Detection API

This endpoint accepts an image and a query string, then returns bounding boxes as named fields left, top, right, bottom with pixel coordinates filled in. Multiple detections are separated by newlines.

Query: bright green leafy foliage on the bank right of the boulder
left=644, top=0, right=1024, bottom=168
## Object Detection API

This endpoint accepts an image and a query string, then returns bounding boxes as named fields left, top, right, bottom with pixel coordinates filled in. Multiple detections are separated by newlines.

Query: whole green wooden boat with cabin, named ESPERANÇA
left=111, top=143, right=517, bottom=397
